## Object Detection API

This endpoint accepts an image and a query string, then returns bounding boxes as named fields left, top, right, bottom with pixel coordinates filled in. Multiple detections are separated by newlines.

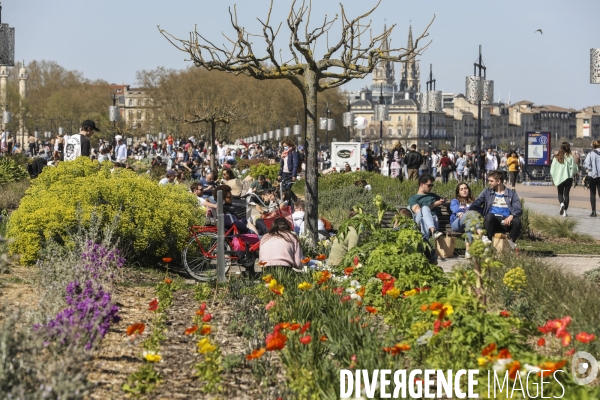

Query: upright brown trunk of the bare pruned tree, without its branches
left=303, top=70, right=319, bottom=247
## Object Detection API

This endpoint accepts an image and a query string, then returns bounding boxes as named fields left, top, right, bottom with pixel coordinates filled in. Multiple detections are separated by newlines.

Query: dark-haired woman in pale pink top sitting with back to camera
left=260, top=218, right=303, bottom=269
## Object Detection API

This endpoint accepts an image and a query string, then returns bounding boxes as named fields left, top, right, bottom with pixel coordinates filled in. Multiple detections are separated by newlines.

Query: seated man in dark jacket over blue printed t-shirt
left=471, top=171, right=523, bottom=242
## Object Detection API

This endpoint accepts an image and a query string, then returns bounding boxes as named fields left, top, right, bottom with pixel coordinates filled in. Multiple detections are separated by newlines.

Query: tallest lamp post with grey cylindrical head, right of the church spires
left=465, top=45, right=494, bottom=178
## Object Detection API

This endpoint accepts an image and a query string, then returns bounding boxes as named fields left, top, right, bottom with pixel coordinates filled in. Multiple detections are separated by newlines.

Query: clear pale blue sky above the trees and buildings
left=8, top=0, right=600, bottom=108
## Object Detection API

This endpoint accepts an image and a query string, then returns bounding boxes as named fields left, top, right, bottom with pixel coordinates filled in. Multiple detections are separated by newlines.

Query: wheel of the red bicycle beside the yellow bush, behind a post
left=181, top=232, right=231, bottom=282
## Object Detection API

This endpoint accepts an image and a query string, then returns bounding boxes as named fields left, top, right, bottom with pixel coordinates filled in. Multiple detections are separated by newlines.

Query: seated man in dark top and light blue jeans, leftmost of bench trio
left=408, top=174, right=448, bottom=240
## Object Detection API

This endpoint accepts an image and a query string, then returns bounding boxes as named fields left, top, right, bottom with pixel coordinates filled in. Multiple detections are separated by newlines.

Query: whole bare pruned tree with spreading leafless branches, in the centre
left=158, top=0, right=435, bottom=246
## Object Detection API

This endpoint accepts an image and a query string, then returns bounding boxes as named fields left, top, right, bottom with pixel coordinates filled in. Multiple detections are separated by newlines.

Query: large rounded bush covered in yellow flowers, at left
left=7, top=157, right=204, bottom=263
